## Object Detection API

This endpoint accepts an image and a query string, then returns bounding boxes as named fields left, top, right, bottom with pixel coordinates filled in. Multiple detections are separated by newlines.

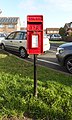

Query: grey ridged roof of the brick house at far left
left=0, top=17, right=19, bottom=24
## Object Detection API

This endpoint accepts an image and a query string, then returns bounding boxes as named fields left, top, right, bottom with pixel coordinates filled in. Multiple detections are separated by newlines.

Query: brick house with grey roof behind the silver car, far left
left=0, top=17, right=20, bottom=33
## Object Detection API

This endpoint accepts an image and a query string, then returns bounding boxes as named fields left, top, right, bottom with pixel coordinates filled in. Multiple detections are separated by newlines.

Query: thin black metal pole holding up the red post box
left=34, top=54, right=37, bottom=97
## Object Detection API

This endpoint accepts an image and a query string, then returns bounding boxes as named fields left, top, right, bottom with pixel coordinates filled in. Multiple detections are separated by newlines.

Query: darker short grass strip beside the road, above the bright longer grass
left=0, top=51, right=72, bottom=86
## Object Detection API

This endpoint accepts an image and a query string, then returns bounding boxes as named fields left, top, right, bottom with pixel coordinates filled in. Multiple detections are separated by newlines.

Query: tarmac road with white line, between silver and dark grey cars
left=27, top=48, right=69, bottom=74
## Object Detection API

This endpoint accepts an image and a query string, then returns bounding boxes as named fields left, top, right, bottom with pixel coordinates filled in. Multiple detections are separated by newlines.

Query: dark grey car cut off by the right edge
left=56, top=42, right=72, bottom=74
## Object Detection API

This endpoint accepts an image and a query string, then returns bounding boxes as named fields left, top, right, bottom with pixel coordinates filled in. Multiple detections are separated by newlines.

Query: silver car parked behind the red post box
left=1, top=31, right=50, bottom=58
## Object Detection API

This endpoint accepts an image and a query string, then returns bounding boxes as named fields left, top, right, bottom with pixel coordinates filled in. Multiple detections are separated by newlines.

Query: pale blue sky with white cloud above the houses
left=0, top=0, right=72, bottom=29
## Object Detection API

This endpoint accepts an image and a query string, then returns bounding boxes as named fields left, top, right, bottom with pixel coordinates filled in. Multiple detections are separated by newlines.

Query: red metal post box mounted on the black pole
left=27, top=15, right=43, bottom=54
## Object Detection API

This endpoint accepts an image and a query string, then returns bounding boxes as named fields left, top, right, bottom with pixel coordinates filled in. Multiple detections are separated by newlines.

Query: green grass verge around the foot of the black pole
left=0, top=51, right=72, bottom=120
